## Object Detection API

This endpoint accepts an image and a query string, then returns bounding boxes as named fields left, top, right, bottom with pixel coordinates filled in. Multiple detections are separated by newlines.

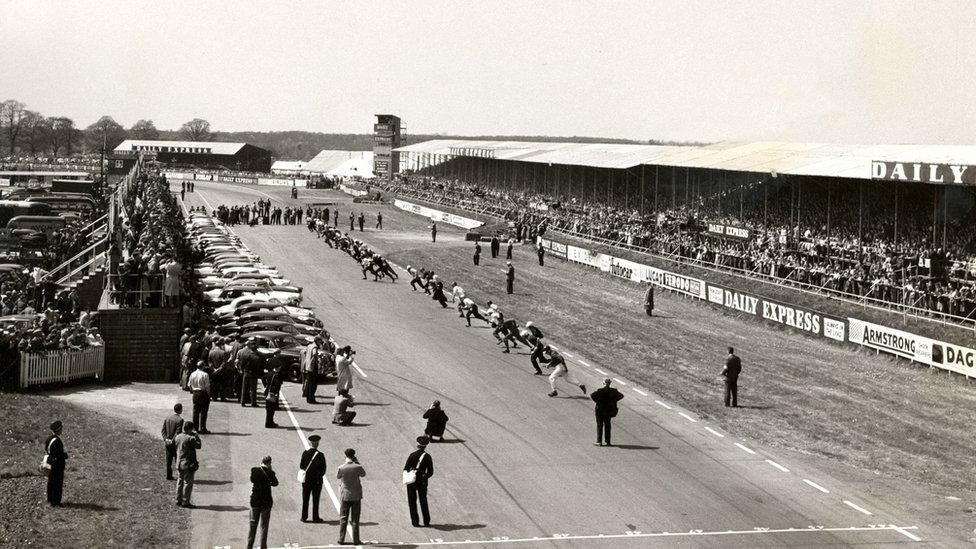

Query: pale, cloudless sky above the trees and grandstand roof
left=0, top=0, right=976, bottom=145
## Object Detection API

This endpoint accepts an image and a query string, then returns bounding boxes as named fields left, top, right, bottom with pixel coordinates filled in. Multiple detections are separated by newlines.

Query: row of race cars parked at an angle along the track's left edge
left=187, top=212, right=335, bottom=381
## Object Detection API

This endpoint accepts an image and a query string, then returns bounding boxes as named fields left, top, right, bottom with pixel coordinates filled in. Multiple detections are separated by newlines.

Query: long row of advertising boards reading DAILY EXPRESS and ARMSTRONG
left=538, top=237, right=976, bottom=377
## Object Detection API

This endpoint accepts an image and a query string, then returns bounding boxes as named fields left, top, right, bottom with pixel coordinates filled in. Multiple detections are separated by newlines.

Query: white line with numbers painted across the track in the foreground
left=264, top=524, right=921, bottom=549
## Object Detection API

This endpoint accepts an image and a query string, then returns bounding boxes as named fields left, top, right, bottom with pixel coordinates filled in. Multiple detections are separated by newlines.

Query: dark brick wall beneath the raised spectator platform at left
left=98, top=309, right=180, bottom=381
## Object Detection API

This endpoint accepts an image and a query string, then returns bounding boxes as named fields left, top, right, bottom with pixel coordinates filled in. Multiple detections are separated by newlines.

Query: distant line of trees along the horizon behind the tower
left=0, top=99, right=697, bottom=160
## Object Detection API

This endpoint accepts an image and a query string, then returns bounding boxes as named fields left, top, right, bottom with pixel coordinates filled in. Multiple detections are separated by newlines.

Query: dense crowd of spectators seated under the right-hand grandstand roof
left=384, top=174, right=976, bottom=318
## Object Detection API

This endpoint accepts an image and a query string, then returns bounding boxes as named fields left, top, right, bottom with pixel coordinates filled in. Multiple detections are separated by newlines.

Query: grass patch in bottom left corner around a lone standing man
left=0, top=393, right=190, bottom=547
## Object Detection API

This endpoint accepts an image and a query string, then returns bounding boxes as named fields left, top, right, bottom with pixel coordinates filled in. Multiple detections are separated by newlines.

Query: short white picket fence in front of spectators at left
left=20, top=345, right=105, bottom=389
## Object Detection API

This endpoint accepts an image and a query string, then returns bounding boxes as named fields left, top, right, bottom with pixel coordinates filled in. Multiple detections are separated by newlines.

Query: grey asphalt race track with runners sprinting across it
left=172, top=182, right=941, bottom=548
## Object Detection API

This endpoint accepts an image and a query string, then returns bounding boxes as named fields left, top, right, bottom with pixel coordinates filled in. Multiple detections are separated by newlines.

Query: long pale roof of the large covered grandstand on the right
left=397, top=139, right=976, bottom=179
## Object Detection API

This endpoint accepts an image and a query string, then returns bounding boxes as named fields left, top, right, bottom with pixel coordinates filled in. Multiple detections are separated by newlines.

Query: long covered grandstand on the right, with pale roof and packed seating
left=394, top=140, right=976, bottom=323
